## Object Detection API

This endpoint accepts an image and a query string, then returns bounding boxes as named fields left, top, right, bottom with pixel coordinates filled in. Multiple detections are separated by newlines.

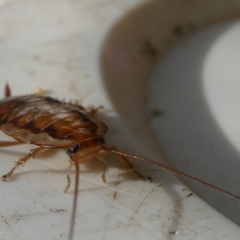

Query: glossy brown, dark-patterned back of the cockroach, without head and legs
left=0, top=95, right=107, bottom=148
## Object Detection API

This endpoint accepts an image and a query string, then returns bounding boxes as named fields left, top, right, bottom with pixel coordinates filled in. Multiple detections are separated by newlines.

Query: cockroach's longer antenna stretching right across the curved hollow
left=109, top=148, right=240, bottom=199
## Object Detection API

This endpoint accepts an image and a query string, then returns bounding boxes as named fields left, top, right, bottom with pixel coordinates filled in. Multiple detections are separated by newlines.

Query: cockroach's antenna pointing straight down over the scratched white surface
left=68, top=161, right=79, bottom=240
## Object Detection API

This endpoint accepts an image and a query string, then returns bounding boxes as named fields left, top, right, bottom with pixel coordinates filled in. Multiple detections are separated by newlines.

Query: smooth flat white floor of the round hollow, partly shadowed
left=148, top=20, right=240, bottom=224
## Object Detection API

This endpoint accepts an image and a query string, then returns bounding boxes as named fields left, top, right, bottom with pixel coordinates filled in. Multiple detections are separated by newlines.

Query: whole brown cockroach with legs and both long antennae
left=0, top=83, right=240, bottom=240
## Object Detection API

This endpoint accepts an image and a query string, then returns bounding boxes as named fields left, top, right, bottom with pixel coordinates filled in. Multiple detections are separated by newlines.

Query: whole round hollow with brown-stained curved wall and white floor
left=102, top=1, right=240, bottom=225
